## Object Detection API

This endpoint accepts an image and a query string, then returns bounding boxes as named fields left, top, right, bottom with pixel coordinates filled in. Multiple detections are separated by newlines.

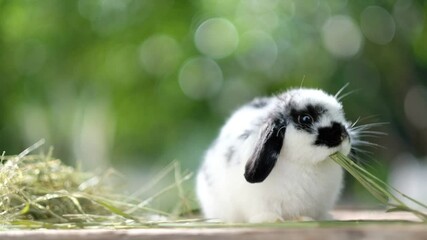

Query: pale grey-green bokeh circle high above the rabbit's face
left=322, top=15, right=363, bottom=58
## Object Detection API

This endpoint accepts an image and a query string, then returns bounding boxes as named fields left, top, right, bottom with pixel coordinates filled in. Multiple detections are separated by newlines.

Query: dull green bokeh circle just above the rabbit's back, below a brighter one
left=178, top=57, right=223, bottom=100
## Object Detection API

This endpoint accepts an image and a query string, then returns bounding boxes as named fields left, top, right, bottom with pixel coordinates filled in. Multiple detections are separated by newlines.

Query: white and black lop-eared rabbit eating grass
left=196, top=88, right=352, bottom=223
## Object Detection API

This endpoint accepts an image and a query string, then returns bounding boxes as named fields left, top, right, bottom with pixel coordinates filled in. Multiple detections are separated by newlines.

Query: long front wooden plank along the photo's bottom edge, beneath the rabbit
left=0, top=225, right=427, bottom=240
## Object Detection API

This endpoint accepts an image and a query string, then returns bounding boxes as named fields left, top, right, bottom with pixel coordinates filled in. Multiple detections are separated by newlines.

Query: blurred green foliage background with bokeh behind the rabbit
left=0, top=0, right=427, bottom=206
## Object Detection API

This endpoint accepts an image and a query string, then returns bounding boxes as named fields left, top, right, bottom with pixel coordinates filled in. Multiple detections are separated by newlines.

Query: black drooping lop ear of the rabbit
left=245, top=117, right=286, bottom=183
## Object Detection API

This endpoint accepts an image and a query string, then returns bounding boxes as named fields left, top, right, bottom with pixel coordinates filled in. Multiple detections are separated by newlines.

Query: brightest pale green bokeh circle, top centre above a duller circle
left=194, top=18, right=239, bottom=58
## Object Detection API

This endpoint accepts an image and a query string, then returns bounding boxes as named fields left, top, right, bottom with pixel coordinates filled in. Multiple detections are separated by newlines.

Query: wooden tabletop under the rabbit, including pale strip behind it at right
left=0, top=211, right=427, bottom=240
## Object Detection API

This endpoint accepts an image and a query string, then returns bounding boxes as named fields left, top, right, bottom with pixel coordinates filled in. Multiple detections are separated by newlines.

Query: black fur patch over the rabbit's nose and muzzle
left=314, top=122, right=348, bottom=148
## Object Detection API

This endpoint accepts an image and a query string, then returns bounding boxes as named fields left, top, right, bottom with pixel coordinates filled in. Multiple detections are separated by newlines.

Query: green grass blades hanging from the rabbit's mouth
left=330, top=152, right=427, bottom=222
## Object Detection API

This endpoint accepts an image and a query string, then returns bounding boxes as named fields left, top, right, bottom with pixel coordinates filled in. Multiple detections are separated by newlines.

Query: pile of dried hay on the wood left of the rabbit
left=0, top=142, right=191, bottom=229
